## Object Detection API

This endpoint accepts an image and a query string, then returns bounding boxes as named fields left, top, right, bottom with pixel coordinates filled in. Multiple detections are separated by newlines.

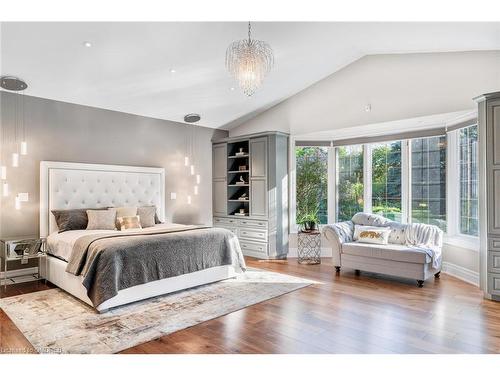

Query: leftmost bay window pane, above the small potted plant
left=295, top=147, right=328, bottom=224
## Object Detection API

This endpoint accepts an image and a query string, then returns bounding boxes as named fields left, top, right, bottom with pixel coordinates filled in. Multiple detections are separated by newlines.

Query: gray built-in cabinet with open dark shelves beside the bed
left=213, top=132, right=288, bottom=259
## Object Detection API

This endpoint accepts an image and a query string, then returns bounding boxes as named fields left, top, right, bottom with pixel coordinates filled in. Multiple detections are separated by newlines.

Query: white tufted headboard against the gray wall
left=40, top=161, right=165, bottom=237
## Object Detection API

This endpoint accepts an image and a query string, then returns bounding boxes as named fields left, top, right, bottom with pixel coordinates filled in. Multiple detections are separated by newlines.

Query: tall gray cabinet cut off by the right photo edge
left=476, top=92, right=500, bottom=301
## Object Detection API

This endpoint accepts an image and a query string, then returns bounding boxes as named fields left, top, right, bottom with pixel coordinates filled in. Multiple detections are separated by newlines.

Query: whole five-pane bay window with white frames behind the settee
left=295, top=121, right=479, bottom=247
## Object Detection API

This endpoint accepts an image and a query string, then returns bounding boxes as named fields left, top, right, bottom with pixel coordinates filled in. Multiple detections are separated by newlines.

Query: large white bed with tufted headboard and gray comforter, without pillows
left=40, top=161, right=245, bottom=312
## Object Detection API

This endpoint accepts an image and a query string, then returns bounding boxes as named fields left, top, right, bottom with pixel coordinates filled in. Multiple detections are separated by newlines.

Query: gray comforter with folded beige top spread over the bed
left=66, top=226, right=245, bottom=306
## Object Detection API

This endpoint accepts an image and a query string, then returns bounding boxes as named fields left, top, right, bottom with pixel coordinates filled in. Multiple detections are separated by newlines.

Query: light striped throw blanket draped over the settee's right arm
left=405, top=223, right=443, bottom=269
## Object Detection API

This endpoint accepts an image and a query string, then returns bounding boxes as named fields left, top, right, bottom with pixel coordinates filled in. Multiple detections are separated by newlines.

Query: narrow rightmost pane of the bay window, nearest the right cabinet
left=459, top=125, right=479, bottom=236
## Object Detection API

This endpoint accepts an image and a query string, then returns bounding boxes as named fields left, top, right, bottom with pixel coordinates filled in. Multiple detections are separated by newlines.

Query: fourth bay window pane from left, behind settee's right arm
left=411, top=136, right=446, bottom=231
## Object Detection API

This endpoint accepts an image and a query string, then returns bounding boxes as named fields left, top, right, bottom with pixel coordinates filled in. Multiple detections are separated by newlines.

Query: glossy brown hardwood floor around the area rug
left=0, top=259, right=500, bottom=353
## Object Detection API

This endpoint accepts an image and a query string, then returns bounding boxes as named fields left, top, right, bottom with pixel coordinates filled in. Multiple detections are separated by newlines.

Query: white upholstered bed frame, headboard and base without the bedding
left=40, top=161, right=236, bottom=312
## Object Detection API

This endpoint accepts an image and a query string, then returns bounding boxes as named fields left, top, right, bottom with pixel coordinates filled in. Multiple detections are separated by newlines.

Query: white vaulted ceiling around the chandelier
left=0, top=22, right=500, bottom=128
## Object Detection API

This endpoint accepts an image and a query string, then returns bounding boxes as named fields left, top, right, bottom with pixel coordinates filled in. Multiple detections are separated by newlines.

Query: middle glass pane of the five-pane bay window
left=371, top=141, right=401, bottom=222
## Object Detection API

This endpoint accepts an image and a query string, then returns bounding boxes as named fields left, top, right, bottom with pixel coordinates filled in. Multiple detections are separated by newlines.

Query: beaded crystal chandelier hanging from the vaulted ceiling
left=226, top=22, right=274, bottom=96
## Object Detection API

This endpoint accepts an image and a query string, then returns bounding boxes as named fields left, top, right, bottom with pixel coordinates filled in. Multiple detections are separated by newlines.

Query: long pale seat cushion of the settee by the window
left=342, top=242, right=431, bottom=264
